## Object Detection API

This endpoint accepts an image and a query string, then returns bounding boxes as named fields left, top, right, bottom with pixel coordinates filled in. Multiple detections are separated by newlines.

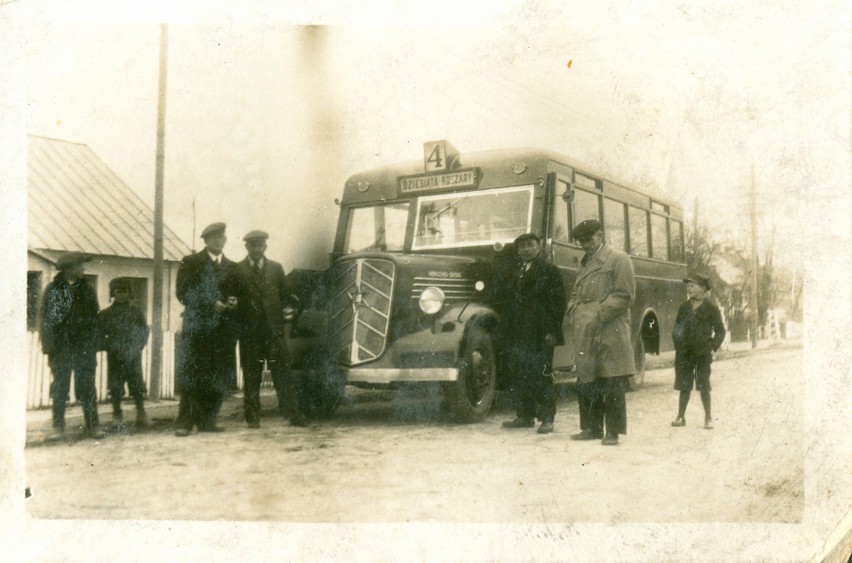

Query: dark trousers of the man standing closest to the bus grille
left=240, top=326, right=300, bottom=422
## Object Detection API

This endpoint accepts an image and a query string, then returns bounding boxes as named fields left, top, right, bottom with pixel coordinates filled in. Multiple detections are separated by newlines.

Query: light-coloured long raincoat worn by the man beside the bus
left=568, top=244, right=636, bottom=383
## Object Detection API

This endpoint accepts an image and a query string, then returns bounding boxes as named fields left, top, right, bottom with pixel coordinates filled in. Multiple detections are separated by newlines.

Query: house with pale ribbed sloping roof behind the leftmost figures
left=27, top=136, right=191, bottom=406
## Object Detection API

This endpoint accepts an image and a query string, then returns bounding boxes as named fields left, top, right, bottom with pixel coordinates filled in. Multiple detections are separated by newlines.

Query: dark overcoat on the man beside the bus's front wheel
left=501, top=257, right=565, bottom=350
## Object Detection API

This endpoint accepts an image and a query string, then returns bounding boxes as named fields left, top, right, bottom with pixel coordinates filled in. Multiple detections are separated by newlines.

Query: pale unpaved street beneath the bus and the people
left=25, top=347, right=804, bottom=523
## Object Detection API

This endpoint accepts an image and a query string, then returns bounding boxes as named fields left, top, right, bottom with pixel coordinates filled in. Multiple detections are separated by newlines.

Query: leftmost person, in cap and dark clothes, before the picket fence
left=41, top=252, right=104, bottom=440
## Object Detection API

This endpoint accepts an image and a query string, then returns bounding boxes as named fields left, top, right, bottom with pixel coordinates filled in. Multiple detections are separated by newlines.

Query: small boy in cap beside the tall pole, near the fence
left=98, top=278, right=149, bottom=427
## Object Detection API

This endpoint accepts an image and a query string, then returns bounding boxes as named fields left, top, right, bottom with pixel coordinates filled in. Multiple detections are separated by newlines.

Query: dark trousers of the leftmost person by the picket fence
left=50, top=350, right=98, bottom=429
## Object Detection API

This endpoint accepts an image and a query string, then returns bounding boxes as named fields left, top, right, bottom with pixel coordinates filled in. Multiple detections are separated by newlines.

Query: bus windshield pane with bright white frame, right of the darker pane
left=412, top=186, right=533, bottom=250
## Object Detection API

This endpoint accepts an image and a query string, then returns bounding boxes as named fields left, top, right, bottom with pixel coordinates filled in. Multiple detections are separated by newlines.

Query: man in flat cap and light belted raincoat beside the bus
left=568, top=219, right=636, bottom=446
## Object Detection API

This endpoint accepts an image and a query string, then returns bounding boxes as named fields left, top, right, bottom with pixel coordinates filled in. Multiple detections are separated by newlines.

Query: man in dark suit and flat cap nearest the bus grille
left=237, top=231, right=307, bottom=428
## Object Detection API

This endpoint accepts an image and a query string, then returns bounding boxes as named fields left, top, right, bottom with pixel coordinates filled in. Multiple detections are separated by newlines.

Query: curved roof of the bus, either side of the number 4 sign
left=343, top=148, right=681, bottom=209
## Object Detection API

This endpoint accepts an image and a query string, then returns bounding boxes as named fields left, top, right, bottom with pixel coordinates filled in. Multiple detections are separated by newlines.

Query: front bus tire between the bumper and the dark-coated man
left=443, top=327, right=497, bottom=423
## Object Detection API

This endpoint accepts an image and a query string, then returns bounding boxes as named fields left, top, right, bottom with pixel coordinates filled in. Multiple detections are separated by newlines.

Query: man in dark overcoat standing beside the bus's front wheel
left=500, top=233, right=565, bottom=434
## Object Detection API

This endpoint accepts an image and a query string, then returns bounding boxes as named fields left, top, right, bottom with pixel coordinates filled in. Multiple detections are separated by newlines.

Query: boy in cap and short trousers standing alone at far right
left=672, top=274, right=725, bottom=430
